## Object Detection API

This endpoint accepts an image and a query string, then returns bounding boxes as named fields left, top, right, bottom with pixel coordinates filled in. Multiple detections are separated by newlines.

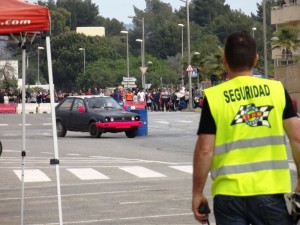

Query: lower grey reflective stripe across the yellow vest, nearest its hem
left=211, top=160, right=289, bottom=179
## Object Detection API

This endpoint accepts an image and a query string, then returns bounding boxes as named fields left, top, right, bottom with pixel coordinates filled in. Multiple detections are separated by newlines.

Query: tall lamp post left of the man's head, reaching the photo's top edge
left=180, top=0, right=193, bottom=109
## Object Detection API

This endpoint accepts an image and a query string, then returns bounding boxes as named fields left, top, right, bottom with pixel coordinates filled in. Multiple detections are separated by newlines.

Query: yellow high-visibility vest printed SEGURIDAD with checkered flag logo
left=205, top=76, right=291, bottom=196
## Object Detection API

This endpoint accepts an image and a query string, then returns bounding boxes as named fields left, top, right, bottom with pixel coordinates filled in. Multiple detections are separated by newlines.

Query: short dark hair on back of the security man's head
left=225, top=31, right=256, bottom=72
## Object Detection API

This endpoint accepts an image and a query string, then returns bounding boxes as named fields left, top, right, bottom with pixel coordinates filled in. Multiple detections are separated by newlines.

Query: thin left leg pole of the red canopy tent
left=21, top=46, right=26, bottom=225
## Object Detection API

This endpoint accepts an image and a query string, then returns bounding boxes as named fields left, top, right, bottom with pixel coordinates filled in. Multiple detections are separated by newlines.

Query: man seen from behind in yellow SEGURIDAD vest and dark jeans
left=192, top=31, right=300, bottom=225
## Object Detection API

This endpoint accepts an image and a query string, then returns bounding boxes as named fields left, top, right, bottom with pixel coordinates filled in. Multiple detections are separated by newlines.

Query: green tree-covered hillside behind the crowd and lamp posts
left=1, top=0, right=277, bottom=91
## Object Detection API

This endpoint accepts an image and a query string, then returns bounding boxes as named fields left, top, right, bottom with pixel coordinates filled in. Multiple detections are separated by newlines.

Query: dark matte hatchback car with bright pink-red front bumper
left=55, top=95, right=143, bottom=138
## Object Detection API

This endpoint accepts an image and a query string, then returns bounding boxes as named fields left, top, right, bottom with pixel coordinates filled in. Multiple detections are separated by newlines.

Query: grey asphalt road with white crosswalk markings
left=0, top=112, right=296, bottom=225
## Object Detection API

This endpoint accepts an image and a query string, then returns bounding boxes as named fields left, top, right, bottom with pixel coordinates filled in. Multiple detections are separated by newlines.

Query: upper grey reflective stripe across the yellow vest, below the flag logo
left=214, top=136, right=286, bottom=155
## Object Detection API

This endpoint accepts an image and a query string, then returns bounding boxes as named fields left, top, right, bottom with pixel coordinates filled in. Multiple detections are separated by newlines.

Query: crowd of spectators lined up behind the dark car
left=0, top=78, right=209, bottom=112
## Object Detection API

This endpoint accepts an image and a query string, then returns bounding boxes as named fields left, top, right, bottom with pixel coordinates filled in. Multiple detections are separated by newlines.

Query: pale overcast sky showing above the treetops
left=92, top=0, right=262, bottom=24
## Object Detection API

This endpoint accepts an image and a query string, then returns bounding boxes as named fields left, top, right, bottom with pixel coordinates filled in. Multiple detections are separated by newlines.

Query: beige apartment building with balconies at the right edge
left=271, top=0, right=300, bottom=112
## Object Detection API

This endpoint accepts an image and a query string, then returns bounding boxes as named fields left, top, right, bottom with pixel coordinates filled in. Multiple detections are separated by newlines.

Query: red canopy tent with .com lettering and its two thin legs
left=0, top=0, right=62, bottom=225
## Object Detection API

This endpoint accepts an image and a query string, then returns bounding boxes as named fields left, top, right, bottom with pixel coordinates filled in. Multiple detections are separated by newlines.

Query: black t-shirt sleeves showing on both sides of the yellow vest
left=197, top=90, right=297, bottom=135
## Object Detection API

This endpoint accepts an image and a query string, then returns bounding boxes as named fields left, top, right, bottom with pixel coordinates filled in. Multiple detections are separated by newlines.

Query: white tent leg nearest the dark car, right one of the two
left=46, top=34, right=63, bottom=225
